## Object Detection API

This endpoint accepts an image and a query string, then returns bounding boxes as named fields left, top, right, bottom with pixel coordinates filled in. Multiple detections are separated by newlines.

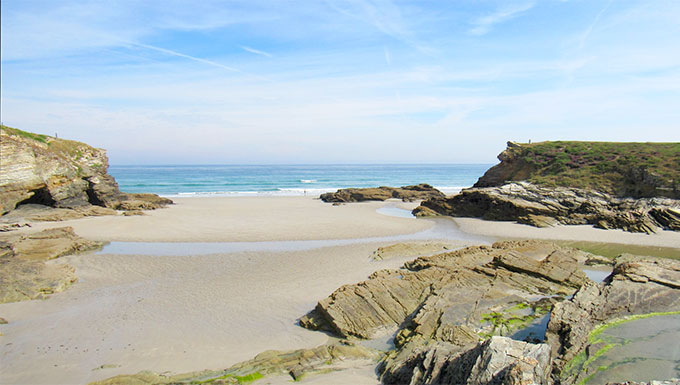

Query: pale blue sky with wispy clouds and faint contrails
left=0, top=0, right=680, bottom=165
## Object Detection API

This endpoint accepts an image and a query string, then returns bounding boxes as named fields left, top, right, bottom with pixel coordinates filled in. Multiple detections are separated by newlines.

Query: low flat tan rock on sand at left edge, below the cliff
left=0, top=227, right=103, bottom=303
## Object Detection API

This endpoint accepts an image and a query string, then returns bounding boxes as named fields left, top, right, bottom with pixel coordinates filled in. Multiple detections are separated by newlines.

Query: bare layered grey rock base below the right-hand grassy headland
left=414, top=182, right=680, bottom=233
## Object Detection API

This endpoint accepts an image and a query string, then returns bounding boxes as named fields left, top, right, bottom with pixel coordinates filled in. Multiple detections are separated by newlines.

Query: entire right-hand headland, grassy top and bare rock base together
left=413, top=142, right=680, bottom=233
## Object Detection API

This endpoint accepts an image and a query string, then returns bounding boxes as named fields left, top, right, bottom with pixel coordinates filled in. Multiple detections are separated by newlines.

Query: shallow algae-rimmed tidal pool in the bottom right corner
left=586, top=314, right=680, bottom=385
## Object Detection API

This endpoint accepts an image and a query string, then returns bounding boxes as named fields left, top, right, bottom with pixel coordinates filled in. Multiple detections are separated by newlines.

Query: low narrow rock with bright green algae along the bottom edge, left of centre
left=93, top=341, right=382, bottom=385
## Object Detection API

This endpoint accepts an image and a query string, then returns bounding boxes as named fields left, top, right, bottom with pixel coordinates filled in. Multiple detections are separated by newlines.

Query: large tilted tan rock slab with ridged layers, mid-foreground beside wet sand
left=300, top=242, right=587, bottom=338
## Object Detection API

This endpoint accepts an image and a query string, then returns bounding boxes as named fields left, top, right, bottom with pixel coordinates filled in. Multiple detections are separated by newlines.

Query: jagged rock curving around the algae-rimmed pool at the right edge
left=546, top=256, right=680, bottom=384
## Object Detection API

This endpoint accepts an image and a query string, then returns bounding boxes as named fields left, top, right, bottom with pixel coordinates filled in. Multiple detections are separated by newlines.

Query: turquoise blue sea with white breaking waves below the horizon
left=109, top=164, right=492, bottom=197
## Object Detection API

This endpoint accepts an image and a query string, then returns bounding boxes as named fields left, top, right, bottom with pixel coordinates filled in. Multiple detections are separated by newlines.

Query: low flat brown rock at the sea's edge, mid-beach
left=319, top=184, right=445, bottom=203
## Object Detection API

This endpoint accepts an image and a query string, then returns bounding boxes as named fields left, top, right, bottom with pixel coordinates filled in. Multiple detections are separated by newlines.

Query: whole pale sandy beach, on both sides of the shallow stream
left=0, top=197, right=680, bottom=384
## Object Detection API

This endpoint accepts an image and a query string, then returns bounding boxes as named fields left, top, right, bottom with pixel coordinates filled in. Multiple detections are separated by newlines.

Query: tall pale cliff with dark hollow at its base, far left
left=0, top=126, right=172, bottom=214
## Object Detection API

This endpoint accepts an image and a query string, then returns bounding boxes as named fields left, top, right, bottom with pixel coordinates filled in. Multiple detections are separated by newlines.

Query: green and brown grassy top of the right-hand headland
left=475, top=141, right=680, bottom=198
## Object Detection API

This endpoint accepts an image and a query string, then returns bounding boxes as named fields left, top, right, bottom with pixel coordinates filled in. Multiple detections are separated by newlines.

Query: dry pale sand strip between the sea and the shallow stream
left=18, top=196, right=432, bottom=242
